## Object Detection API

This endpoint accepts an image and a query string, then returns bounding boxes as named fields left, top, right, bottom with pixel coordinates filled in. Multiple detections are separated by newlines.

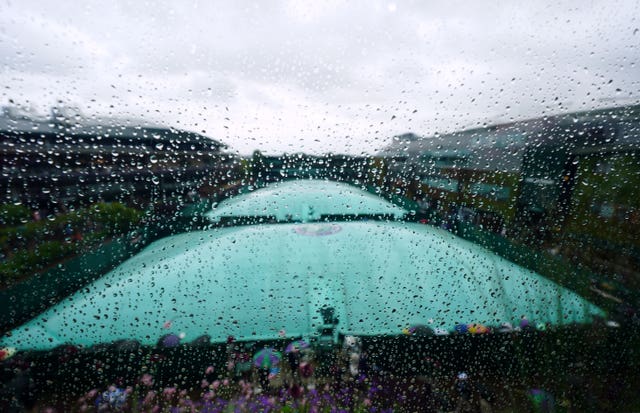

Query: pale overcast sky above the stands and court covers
left=0, top=0, right=640, bottom=154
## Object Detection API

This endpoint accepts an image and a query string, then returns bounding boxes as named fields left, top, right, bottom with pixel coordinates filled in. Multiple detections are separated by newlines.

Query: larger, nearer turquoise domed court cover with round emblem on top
left=0, top=216, right=603, bottom=349
